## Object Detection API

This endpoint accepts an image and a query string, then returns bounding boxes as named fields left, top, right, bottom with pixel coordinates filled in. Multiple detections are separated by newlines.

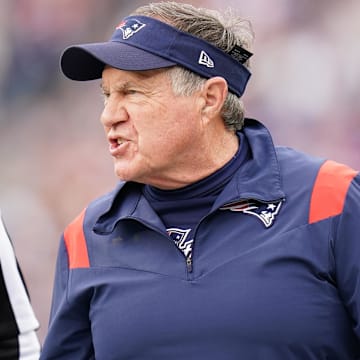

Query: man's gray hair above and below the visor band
left=134, top=1, right=254, bottom=131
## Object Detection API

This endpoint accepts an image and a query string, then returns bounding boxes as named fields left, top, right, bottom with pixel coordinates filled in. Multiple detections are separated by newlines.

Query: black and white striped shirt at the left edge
left=0, top=213, right=40, bottom=360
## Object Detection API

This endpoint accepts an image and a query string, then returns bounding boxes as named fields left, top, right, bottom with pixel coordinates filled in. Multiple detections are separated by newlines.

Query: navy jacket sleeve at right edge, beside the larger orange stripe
left=332, top=174, right=360, bottom=344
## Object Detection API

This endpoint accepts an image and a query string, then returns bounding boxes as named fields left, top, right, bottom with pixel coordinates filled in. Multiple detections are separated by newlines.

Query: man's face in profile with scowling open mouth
left=101, top=67, right=202, bottom=189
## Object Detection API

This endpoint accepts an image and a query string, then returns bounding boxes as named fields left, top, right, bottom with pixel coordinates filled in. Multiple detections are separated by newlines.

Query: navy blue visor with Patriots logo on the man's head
left=60, top=16, right=251, bottom=97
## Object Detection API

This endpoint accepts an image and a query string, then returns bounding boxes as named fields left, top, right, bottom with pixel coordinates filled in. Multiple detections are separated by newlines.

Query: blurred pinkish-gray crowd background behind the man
left=0, top=0, right=360, bottom=341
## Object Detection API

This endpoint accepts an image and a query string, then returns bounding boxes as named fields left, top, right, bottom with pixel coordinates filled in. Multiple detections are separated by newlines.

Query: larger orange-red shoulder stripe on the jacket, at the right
left=309, top=160, right=357, bottom=224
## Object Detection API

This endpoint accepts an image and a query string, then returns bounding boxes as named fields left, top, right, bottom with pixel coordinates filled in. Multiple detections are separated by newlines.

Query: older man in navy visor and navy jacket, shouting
left=42, top=2, right=360, bottom=360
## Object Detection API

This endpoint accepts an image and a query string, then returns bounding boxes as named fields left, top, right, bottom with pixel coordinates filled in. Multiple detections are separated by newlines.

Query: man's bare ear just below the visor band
left=202, top=76, right=228, bottom=119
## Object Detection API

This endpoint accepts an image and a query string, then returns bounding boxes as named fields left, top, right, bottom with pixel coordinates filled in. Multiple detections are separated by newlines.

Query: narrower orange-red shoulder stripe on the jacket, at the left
left=64, top=209, right=90, bottom=269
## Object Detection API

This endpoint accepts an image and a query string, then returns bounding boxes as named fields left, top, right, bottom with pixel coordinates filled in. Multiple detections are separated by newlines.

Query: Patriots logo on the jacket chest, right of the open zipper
left=220, top=200, right=282, bottom=228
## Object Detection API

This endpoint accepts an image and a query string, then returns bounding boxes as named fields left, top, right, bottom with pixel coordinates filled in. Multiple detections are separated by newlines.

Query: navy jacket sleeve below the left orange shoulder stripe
left=40, top=232, right=95, bottom=360
